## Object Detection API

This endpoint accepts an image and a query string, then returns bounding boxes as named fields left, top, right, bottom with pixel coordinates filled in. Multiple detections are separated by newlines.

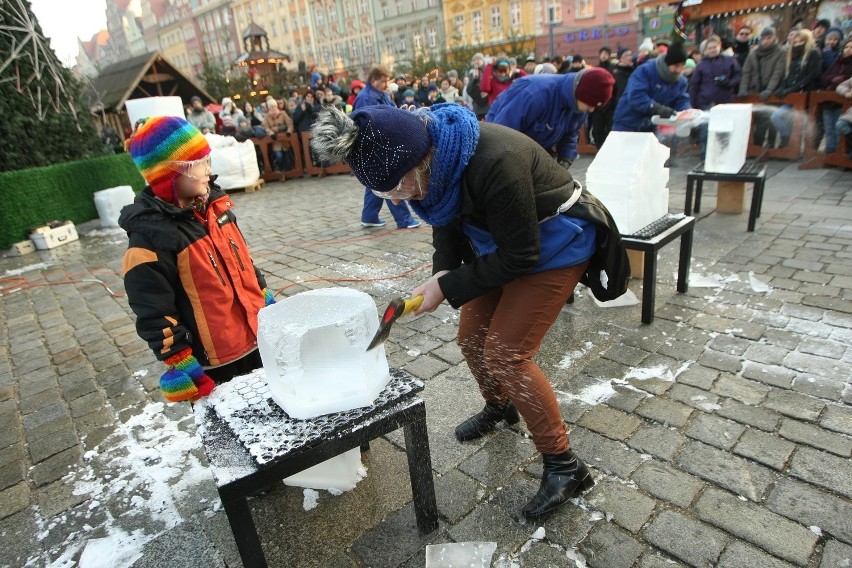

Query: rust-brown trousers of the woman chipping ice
left=457, top=262, right=588, bottom=454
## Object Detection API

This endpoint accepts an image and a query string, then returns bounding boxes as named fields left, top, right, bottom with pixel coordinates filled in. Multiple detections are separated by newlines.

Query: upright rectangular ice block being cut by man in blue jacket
left=704, top=104, right=752, bottom=174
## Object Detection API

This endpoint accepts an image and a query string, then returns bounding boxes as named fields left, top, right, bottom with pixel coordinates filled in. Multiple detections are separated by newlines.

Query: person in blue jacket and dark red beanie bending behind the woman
left=485, top=67, right=615, bottom=168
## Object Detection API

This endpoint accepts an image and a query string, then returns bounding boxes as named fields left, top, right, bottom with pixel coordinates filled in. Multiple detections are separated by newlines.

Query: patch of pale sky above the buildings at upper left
left=30, top=0, right=106, bottom=67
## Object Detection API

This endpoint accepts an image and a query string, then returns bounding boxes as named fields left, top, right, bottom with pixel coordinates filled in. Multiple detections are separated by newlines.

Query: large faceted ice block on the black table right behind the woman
left=586, top=132, right=669, bottom=234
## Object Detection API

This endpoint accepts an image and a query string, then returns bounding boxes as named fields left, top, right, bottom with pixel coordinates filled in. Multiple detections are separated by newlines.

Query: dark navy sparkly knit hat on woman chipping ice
left=346, top=105, right=432, bottom=191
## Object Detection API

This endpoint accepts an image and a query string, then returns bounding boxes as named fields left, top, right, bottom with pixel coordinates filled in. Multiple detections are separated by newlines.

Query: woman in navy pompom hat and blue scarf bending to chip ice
left=311, top=104, right=629, bottom=520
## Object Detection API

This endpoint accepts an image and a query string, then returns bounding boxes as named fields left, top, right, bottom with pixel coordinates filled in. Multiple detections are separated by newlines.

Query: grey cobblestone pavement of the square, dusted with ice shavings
left=0, top=159, right=852, bottom=568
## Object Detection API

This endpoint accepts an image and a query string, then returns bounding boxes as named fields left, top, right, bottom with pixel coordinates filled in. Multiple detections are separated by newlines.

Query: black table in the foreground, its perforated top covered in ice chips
left=194, top=369, right=438, bottom=568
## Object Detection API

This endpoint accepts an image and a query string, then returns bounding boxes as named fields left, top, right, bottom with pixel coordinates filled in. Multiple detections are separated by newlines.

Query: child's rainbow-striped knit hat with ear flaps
left=129, top=116, right=210, bottom=205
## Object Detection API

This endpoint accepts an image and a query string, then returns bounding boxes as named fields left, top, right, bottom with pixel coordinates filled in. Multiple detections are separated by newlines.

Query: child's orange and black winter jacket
left=119, top=183, right=266, bottom=367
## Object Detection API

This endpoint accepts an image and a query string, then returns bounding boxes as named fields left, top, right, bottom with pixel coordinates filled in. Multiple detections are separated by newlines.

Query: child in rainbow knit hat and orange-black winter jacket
left=119, top=116, right=274, bottom=402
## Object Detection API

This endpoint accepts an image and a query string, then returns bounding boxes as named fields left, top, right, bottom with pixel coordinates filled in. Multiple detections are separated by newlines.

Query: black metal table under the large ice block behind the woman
left=621, top=214, right=695, bottom=324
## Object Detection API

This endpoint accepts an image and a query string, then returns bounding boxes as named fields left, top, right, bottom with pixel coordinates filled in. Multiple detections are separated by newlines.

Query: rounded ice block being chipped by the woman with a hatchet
left=257, top=288, right=390, bottom=419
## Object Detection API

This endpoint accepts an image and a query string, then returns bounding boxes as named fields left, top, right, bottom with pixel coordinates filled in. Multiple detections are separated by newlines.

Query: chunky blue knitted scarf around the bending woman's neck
left=409, top=103, right=479, bottom=227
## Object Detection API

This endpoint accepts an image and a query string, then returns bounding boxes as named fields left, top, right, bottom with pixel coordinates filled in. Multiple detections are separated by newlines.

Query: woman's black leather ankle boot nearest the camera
left=521, top=450, right=595, bottom=520
